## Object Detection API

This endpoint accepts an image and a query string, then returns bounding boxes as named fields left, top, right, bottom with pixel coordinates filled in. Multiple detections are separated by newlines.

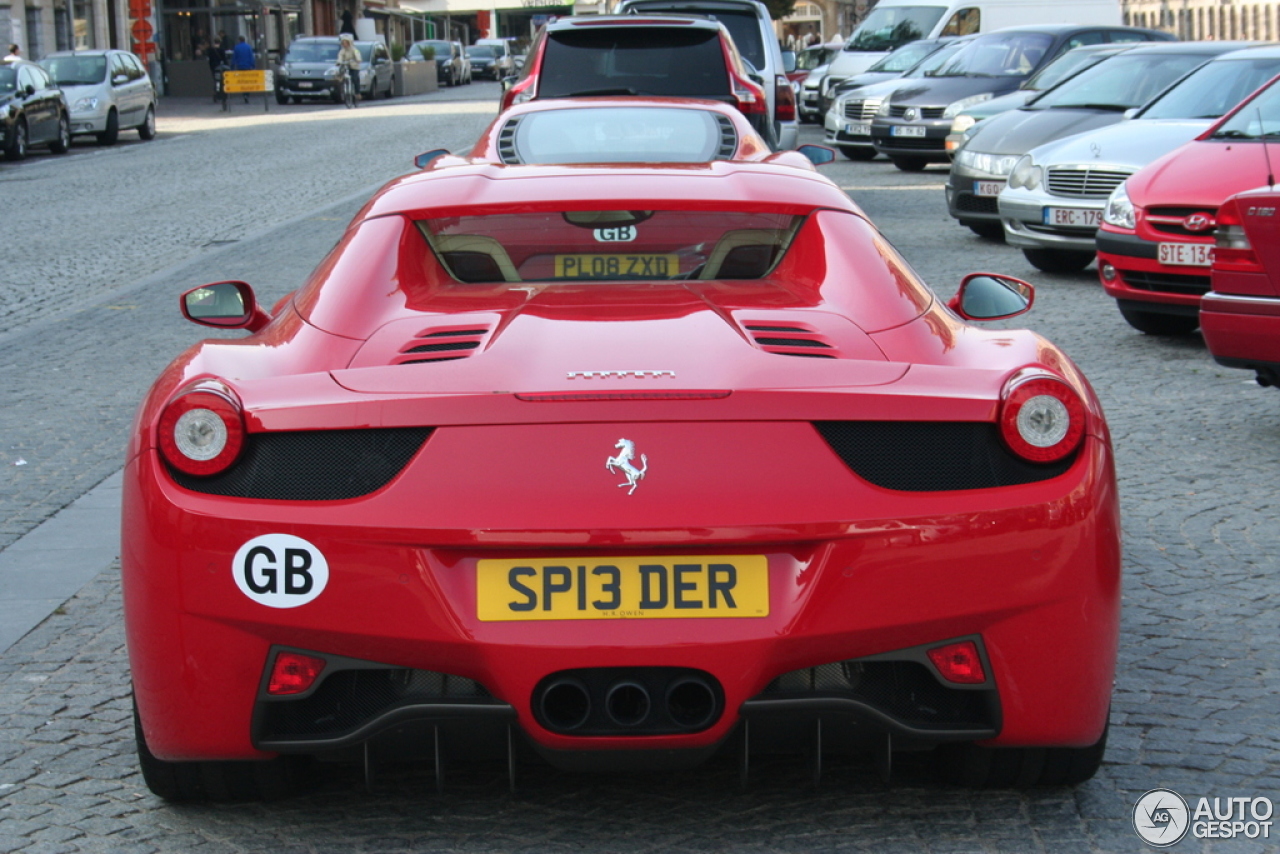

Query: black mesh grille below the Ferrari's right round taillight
left=814, top=421, right=1075, bottom=492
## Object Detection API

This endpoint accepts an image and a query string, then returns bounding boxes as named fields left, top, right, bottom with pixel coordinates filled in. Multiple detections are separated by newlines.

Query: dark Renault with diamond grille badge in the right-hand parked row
left=872, top=24, right=1167, bottom=172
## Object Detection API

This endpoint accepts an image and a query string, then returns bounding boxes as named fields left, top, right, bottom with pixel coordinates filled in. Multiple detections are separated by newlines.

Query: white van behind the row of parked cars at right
left=823, top=0, right=1124, bottom=91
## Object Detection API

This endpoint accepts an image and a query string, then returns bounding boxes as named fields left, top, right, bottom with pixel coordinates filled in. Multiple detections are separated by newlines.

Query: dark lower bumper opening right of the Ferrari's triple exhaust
left=759, top=661, right=995, bottom=729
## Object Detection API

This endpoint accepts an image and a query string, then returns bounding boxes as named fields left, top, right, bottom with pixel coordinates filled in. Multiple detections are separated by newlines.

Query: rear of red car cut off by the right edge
left=1199, top=186, right=1280, bottom=385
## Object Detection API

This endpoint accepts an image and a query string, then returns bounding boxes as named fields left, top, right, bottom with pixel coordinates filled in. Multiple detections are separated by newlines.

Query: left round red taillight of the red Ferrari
left=160, top=392, right=244, bottom=476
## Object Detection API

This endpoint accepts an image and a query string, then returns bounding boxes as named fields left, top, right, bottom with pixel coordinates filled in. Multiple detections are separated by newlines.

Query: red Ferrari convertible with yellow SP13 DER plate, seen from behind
left=122, top=150, right=1120, bottom=799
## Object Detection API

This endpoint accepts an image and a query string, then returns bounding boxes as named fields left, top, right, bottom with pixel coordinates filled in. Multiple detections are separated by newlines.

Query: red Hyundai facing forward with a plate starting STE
left=1096, top=71, right=1280, bottom=335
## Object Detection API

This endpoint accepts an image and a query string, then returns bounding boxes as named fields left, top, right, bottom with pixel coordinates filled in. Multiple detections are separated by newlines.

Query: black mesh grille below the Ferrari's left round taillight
left=169, top=428, right=431, bottom=501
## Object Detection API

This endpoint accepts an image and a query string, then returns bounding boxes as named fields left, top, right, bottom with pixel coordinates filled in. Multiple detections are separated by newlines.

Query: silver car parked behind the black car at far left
left=40, top=50, right=156, bottom=145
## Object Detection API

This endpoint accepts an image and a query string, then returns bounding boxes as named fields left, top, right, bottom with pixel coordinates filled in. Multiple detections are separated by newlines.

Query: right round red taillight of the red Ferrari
left=1000, top=378, right=1085, bottom=462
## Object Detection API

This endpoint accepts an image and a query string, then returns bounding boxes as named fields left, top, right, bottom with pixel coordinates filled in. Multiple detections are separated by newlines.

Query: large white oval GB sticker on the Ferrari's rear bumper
left=232, top=534, right=329, bottom=608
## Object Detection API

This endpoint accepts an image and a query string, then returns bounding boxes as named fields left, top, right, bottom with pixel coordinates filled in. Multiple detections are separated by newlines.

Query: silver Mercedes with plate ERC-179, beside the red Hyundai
left=998, top=42, right=1280, bottom=271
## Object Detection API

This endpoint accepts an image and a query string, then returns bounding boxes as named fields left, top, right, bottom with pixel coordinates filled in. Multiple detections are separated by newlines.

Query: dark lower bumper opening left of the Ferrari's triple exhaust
left=257, top=667, right=492, bottom=741
